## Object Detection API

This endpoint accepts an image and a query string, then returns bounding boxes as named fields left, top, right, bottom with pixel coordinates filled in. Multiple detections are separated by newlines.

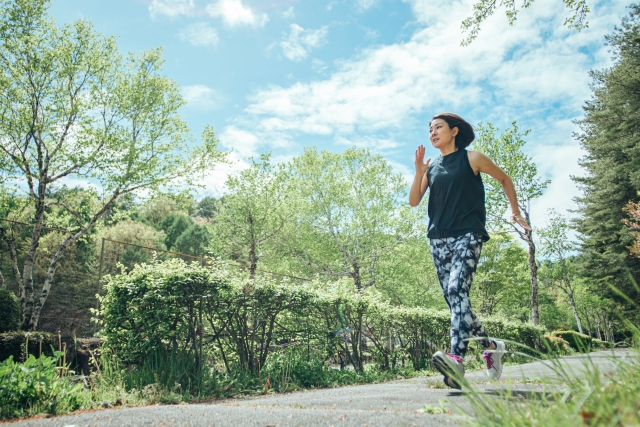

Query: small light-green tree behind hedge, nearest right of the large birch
left=210, top=154, right=290, bottom=278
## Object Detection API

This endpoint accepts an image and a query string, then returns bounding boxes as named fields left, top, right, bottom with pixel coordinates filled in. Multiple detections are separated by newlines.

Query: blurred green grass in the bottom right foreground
left=468, top=340, right=640, bottom=427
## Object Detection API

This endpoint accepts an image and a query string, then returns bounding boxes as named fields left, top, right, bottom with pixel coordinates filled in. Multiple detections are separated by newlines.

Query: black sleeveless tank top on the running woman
left=427, top=149, right=489, bottom=242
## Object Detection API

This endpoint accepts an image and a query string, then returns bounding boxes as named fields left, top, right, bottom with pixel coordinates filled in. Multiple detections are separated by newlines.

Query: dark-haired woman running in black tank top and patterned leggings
left=409, top=113, right=531, bottom=388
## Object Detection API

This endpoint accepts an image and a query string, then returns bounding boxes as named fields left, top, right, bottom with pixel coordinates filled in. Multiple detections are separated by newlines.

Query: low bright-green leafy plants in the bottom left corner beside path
left=0, top=352, right=82, bottom=419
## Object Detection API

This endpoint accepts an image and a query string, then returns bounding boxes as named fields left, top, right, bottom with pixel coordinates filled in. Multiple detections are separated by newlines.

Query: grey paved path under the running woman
left=11, top=350, right=635, bottom=427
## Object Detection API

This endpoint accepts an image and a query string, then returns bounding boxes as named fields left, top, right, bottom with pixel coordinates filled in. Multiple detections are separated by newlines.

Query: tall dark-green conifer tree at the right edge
left=573, top=5, right=640, bottom=320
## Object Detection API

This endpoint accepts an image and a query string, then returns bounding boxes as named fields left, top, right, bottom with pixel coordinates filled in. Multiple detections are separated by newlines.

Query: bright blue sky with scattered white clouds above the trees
left=51, top=0, right=629, bottom=226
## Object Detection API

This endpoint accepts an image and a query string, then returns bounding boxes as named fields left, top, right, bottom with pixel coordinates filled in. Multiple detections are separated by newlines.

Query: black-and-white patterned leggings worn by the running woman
left=430, top=233, right=491, bottom=357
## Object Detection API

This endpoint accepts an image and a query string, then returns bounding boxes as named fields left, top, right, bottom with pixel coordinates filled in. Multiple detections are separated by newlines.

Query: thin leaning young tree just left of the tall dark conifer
left=540, top=209, right=584, bottom=334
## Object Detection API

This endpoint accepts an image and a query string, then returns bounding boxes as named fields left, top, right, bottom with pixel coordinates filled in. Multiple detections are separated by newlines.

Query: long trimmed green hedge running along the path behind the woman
left=101, top=260, right=544, bottom=372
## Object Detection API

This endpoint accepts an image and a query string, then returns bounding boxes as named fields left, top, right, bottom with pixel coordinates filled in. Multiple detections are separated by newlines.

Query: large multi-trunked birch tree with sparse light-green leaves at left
left=0, top=0, right=228, bottom=329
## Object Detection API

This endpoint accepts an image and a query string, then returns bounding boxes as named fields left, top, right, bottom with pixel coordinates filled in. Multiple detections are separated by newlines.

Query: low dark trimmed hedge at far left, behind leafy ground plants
left=0, top=331, right=58, bottom=362
